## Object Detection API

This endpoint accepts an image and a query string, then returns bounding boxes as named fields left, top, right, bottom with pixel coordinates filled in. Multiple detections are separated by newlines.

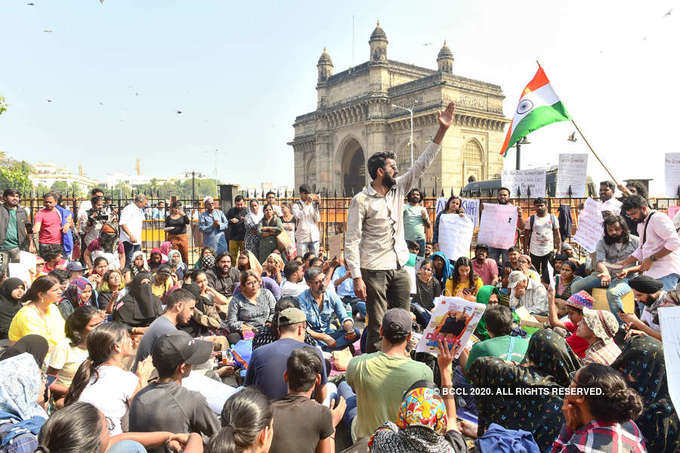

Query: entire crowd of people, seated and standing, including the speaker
left=0, top=100, right=680, bottom=453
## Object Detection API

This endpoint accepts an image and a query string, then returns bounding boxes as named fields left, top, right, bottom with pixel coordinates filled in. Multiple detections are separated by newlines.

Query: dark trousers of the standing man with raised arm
left=361, top=268, right=411, bottom=353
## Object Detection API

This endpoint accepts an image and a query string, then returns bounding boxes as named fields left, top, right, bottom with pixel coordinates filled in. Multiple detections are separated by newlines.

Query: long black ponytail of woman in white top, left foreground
left=64, top=322, right=129, bottom=406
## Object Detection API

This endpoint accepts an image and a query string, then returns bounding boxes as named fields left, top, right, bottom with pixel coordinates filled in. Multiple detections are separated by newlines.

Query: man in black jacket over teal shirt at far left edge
left=0, top=189, right=35, bottom=262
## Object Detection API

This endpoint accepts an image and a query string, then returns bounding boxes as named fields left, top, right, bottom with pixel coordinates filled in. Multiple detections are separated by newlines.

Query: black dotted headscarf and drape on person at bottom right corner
left=611, top=336, right=680, bottom=453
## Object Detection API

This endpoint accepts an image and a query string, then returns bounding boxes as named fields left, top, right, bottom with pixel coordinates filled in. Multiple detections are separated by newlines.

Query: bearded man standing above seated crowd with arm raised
left=345, top=102, right=456, bottom=353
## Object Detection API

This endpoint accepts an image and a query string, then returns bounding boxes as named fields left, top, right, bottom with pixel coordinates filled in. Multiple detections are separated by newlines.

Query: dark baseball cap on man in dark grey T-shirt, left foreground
left=151, top=331, right=213, bottom=376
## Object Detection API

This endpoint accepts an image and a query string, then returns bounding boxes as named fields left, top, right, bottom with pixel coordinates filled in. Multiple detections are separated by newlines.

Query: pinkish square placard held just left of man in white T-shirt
left=477, top=203, right=517, bottom=250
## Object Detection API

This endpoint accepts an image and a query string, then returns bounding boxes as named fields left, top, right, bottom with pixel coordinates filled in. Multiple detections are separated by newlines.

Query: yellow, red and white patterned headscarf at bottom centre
left=397, top=387, right=448, bottom=436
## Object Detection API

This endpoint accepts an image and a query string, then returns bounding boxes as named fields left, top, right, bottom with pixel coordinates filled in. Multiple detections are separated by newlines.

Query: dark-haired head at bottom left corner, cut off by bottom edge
left=36, top=402, right=104, bottom=453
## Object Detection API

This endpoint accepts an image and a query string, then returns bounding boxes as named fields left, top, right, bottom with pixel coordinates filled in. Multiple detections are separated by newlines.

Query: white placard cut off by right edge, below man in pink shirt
left=659, top=307, right=680, bottom=412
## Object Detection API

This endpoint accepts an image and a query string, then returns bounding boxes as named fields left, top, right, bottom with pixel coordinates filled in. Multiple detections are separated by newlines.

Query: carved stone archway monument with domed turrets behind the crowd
left=289, top=24, right=509, bottom=195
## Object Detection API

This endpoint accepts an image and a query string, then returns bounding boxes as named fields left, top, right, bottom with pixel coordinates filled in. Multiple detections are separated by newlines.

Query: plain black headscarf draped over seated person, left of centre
left=113, top=272, right=163, bottom=327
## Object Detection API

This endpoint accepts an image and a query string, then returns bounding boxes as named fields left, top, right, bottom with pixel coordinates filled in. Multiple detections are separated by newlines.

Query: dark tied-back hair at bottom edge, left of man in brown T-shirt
left=215, top=387, right=273, bottom=453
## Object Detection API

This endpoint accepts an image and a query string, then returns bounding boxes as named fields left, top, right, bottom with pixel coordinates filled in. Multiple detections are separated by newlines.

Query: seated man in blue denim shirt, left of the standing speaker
left=298, top=267, right=360, bottom=351
